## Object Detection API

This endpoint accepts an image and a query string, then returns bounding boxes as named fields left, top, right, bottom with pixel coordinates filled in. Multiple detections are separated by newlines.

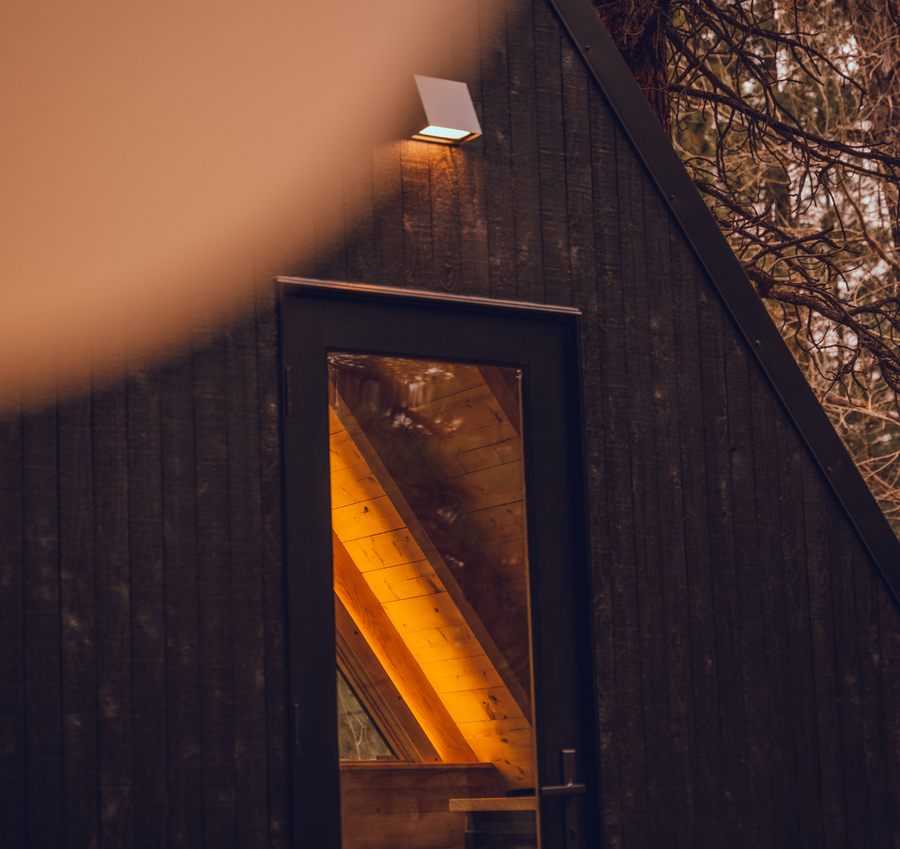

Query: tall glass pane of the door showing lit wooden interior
left=329, top=353, right=538, bottom=849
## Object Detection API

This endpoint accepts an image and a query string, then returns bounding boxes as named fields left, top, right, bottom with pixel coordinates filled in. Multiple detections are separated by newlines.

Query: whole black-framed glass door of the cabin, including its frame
left=281, top=281, right=599, bottom=849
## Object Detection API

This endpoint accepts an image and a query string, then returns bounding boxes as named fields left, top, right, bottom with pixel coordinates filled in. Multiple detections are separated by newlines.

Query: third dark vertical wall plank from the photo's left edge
left=57, top=378, right=99, bottom=847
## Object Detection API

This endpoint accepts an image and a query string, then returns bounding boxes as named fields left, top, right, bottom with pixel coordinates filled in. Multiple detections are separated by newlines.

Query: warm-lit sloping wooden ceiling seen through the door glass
left=330, top=364, right=533, bottom=787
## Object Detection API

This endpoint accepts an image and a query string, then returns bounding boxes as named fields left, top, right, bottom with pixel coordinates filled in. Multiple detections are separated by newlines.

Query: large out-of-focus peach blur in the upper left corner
left=0, top=0, right=492, bottom=411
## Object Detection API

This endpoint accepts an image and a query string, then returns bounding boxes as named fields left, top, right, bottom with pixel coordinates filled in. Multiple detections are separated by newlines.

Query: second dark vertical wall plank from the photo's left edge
left=22, top=393, right=63, bottom=847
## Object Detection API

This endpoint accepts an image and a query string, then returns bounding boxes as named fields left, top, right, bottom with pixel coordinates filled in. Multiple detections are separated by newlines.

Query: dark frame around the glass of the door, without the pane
left=279, top=278, right=600, bottom=849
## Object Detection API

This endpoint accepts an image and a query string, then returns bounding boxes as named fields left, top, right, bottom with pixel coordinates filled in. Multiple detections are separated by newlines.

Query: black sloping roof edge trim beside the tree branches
left=549, top=0, right=900, bottom=603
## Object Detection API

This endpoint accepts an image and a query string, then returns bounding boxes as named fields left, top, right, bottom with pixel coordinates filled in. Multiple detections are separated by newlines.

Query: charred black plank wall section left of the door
left=0, top=286, right=288, bottom=849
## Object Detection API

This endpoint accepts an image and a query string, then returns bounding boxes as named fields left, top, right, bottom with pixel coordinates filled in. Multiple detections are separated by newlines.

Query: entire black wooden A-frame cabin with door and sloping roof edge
left=0, top=0, right=900, bottom=849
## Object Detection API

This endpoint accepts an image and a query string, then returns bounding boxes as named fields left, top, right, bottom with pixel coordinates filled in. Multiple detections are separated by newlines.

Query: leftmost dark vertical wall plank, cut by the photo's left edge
left=0, top=405, right=28, bottom=846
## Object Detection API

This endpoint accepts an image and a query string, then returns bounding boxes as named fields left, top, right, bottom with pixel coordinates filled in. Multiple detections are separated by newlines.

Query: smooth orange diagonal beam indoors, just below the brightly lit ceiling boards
left=331, top=531, right=478, bottom=763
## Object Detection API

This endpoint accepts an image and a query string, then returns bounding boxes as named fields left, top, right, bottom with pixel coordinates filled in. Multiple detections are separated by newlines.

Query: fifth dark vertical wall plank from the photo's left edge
left=126, top=364, right=168, bottom=849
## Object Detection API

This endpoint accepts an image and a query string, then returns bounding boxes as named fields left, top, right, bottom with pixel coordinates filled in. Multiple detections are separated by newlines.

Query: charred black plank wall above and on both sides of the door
left=0, top=0, right=900, bottom=849
